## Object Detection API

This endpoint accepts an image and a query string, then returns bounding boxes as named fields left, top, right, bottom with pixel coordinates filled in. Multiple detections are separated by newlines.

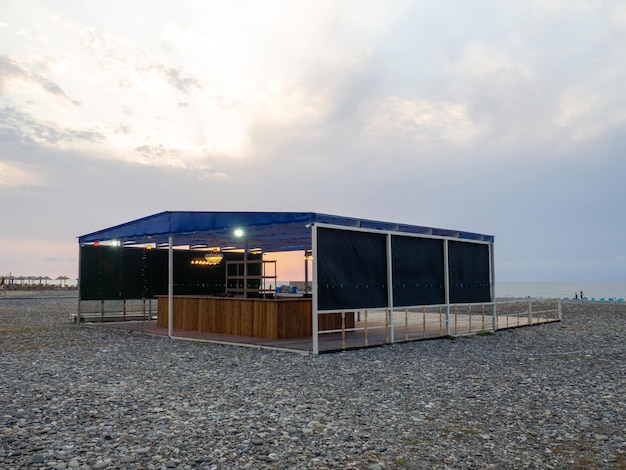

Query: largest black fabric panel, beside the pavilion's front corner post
left=316, top=228, right=388, bottom=310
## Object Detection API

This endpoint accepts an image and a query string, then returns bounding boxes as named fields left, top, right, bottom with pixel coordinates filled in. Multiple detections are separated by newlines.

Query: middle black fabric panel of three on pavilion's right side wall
left=391, top=235, right=446, bottom=307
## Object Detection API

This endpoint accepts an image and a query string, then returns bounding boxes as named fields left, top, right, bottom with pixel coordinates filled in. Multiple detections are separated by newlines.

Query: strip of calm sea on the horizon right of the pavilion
left=496, top=282, right=626, bottom=300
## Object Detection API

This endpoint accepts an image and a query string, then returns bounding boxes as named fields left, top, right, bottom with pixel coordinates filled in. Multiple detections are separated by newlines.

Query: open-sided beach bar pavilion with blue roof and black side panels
left=77, top=211, right=495, bottom=354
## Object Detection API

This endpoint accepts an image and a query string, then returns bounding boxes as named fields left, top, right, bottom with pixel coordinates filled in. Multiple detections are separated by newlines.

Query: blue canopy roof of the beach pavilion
left=78, top=211, right=494, bottom=252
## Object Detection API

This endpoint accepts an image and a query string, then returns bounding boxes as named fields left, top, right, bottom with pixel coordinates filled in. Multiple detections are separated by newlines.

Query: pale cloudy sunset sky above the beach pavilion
left=0, top=0, right=626, bottom=281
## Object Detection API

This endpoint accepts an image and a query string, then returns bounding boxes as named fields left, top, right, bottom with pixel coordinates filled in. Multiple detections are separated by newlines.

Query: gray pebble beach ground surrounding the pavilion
left=0, top=298, right=626, bottom=470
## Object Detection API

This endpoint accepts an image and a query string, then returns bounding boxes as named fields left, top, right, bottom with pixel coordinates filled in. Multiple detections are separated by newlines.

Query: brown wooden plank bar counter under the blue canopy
left=157, top=295, right=354, bottom=339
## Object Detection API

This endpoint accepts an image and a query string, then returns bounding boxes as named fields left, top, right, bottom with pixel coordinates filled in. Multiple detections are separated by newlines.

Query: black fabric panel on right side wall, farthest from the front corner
left=448, top=241, right=491, bottom=303
